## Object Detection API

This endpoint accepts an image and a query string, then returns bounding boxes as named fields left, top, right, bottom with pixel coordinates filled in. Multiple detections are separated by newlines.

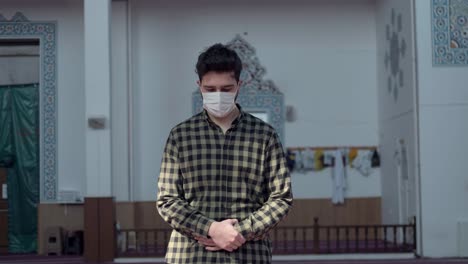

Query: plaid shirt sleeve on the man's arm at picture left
left=156, top=132, right=214, bottom=238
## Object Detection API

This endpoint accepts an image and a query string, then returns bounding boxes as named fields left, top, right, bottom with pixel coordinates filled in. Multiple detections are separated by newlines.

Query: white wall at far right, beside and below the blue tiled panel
left=416, top=0, right=468, bottom=257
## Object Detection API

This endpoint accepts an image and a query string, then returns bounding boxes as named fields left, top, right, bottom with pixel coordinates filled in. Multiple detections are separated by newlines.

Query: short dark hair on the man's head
left=196, top=43, right=242, bottom=82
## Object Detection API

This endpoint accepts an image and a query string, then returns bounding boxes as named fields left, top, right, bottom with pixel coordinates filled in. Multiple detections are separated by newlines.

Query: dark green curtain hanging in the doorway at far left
left=0, top=84, right=39, bottom=253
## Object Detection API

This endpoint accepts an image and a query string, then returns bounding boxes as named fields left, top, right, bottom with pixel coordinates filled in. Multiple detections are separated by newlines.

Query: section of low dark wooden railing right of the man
left=270, top=218, right=416, bottom=255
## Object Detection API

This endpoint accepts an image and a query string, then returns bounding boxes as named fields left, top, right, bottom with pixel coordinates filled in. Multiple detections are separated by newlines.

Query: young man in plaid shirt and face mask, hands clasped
left=156, top=44, right=292, bottom=264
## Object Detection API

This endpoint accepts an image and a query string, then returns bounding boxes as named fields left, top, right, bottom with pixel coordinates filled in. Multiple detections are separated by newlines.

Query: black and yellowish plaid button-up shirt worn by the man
left=156, top=106, right=292, bottom=264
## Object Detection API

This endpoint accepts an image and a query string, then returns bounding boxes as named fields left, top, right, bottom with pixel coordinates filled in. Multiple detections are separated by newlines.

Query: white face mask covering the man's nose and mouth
left=202, top=92, right=236, bottom=118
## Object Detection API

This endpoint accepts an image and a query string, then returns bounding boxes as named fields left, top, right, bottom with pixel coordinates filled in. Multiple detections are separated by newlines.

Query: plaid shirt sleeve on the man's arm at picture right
left=235, top=133, right=293, bottom=240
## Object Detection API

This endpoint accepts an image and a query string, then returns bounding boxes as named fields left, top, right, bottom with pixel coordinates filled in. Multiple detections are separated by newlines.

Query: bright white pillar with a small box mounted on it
left=84, top=0, right=112, bottom=197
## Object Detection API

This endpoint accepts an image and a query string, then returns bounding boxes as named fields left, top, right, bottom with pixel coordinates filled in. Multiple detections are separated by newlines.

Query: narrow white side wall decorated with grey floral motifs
left=376, top=0, right=417, bottom=231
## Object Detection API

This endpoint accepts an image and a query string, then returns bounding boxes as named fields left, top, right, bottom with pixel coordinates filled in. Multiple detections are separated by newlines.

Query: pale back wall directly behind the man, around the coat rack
left=131, top=0, right=381, bottom=200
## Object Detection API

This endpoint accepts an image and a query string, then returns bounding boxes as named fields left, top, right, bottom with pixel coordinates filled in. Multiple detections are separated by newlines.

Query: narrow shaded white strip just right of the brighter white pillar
left=111, top=1, right=133, bottom=201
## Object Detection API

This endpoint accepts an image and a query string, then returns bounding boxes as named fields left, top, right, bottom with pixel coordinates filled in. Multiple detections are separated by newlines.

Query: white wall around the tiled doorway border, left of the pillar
left=0, top=0, right=85, bottom=202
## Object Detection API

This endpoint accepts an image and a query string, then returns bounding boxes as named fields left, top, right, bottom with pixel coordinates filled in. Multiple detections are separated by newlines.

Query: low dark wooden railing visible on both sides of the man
left=116, top=218, right=416, bottom=257
